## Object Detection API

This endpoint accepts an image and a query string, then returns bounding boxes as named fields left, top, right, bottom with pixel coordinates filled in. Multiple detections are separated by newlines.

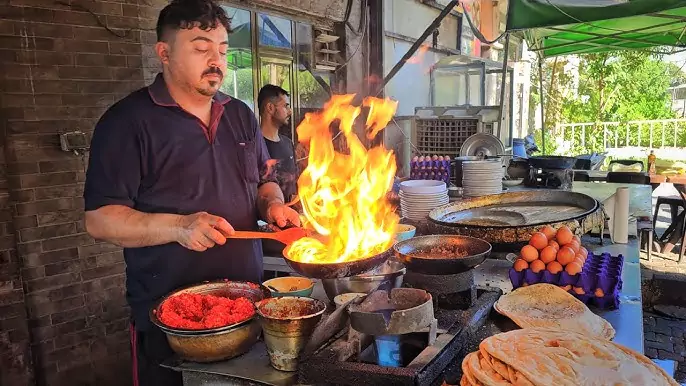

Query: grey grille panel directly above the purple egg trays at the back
left=416, top=118, right=479, bottom=157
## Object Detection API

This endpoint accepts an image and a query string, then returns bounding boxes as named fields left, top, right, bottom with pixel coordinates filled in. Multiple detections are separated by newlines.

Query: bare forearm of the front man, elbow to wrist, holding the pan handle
left=86, top=205, right=183, bottom=248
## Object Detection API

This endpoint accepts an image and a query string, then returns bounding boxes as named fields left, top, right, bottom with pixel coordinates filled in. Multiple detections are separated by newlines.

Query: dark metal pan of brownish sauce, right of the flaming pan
left=393, top=235, right=491, bottom=275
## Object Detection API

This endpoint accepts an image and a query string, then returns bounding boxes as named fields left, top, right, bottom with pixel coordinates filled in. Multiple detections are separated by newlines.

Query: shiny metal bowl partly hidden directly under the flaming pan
left=322, top=259, right=406, bottom=302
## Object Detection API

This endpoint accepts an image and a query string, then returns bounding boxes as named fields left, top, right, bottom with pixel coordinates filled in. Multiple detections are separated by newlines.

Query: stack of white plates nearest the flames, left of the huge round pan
left=400, top=180, right=449, bottom=221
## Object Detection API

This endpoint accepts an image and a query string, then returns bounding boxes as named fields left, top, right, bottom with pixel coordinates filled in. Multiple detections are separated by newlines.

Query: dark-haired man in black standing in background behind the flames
left=257, top=84, right=298, bottom=201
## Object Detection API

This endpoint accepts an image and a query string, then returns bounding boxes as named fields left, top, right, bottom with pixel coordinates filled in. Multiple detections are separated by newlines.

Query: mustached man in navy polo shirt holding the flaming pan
left=84, top=0, right=300, bottom=386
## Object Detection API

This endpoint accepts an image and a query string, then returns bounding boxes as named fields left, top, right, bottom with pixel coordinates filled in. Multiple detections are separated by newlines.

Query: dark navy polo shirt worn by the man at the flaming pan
left=84, top=74, right=269, bottom=330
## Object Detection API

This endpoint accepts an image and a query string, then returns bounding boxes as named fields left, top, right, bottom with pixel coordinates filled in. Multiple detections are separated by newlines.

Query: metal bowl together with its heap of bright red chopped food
left=150, top=280, right=271, bottom=362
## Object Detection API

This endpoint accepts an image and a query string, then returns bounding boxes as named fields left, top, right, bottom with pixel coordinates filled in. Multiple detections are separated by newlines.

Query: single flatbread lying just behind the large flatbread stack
left=495, top=283, right=615, bottom=340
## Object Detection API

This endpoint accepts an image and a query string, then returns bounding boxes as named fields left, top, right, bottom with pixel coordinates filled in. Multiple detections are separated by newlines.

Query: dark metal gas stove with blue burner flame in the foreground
left=298, top=284, right=501, bottom=385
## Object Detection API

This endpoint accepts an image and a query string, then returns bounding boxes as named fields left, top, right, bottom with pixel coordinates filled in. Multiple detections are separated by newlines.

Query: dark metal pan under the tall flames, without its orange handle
left=284, top=249, right=393, bottom=279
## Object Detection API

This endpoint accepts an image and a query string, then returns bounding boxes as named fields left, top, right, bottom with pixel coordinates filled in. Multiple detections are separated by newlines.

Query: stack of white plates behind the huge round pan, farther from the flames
left=462, top=160, right=503, bottom=197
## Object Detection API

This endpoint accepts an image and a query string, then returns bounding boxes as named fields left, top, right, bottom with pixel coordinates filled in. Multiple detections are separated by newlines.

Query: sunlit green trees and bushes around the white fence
left=530, top=51, right=686, bottom=154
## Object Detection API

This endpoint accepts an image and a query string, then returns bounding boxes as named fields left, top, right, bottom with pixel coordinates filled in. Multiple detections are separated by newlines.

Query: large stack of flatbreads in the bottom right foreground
left=460, top=328, right=679, bottom=386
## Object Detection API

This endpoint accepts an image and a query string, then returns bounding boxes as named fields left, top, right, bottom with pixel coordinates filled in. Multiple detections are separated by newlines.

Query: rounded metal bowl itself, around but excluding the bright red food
left=150, top=280, right=271, bottom=362
